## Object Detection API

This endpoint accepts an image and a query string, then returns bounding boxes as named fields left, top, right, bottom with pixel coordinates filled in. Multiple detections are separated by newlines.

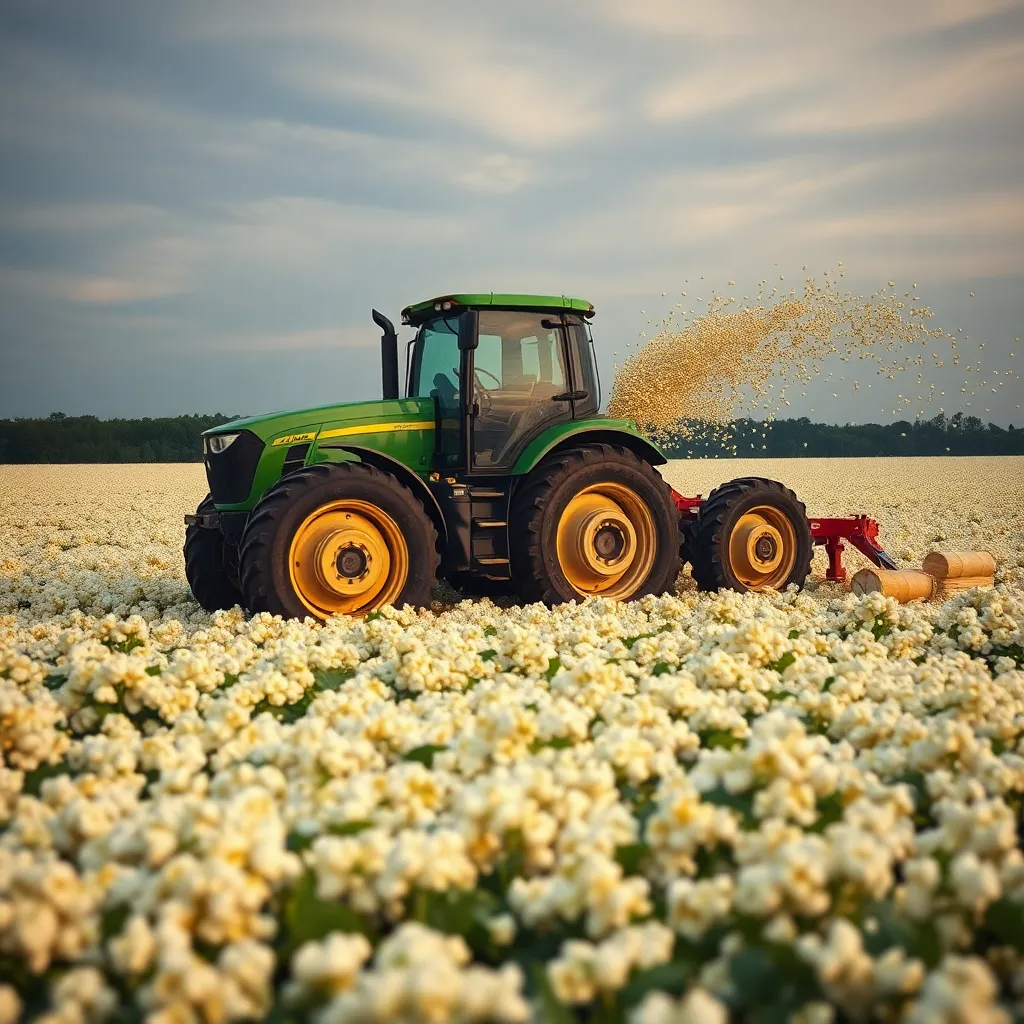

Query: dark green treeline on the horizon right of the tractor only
left=665, top=413, right=1024, bottom=459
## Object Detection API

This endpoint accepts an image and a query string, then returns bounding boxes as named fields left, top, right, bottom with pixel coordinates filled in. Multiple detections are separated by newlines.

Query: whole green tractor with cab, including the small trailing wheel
left=184, top=294, right=812, bottom=620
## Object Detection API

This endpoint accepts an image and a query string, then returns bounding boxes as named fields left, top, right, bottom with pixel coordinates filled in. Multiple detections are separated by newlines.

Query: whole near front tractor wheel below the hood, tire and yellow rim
left=239, top=462, right=439, bottom=620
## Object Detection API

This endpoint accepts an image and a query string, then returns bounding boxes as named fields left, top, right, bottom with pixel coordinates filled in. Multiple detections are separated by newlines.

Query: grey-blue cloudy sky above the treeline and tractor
left=0, top=0, right=1024, bottom=423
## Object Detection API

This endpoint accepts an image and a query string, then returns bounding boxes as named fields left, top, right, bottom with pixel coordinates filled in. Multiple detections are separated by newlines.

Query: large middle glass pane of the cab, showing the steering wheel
left=473, top=309, right=571, bottom=470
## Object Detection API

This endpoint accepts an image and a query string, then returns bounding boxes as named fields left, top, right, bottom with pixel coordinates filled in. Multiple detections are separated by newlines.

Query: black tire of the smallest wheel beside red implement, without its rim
left=686, top=476, right=814, bottom=591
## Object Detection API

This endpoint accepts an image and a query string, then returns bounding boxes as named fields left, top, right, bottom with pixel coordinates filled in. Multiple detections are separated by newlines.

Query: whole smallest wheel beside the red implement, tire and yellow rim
left=686, top=476, right=814, bottom=591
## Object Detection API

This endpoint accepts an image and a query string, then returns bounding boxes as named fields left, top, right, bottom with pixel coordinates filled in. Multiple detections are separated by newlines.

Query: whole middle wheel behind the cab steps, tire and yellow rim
left=509, top=444, right=680, bottom=604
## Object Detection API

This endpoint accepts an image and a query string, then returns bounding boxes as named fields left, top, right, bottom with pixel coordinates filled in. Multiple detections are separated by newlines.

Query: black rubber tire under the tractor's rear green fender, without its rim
left=509, top=444, right=681, bottom=605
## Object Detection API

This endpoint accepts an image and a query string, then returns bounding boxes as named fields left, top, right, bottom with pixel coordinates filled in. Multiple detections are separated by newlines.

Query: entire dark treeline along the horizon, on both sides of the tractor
left=0, top=413, right=1024, bottom=463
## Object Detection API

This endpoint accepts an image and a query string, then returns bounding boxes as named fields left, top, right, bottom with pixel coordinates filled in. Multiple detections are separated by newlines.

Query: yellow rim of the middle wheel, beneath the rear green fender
left=555, top=482, right=657, bottom=601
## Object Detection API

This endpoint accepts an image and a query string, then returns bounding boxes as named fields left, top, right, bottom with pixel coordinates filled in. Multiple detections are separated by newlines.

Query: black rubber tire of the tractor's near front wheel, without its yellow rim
left=239, top=462, right=440, bottom=618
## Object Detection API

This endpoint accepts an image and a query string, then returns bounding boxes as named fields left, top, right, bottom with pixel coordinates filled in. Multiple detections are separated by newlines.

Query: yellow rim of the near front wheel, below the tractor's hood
left=288, top=498, right=409, bottom=618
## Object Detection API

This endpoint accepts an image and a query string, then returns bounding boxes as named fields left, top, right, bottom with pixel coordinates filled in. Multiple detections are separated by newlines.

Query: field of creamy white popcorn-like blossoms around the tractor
left=0, top=459, right=1024, bottom=1024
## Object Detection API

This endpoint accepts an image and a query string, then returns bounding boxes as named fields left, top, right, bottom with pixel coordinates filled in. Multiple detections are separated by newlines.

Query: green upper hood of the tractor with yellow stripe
left=203, top=398, right=434, bottom=443
